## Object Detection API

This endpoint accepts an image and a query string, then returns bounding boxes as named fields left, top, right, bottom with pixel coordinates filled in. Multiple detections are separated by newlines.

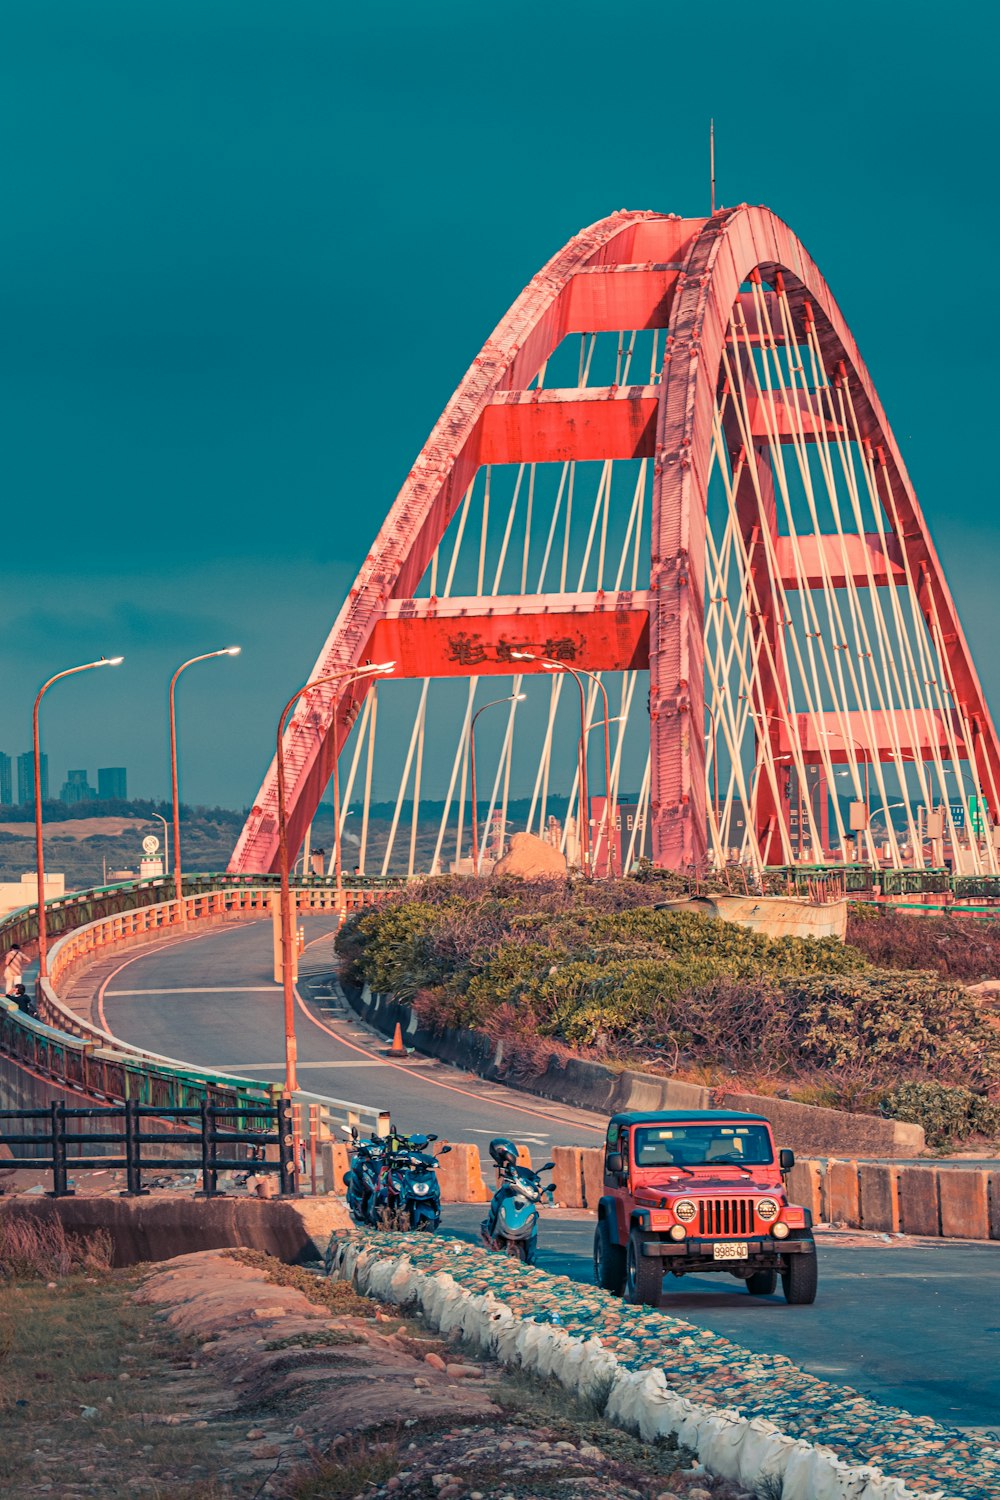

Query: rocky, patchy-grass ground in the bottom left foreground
left=0, top=1251, right=750, bottom=1500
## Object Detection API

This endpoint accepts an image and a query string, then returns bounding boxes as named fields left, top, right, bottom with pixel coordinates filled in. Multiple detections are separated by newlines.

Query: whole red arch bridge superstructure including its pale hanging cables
left=231, top=204, right=1000, bottom=878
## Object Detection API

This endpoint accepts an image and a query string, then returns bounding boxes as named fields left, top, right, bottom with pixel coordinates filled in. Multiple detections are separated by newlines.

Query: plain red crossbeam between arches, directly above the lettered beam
left=475, top=386, right=658, bottom=464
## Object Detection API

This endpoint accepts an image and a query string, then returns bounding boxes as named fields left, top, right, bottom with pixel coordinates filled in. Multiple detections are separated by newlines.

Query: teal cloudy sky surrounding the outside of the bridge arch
left=0, top=0, right=1000, bottom=806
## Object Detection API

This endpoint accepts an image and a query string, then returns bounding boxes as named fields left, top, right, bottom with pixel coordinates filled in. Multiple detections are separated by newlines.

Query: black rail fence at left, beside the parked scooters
left=0, top=1095, right=298, bottom=1199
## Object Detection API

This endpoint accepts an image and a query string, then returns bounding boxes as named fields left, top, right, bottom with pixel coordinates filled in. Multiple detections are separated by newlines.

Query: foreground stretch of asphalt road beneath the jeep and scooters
left=442, top=1205, right=1000, bottom=1433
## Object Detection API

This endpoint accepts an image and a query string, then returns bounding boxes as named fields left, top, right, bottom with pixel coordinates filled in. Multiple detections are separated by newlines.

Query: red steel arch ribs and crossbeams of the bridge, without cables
left=229, top=204, right=1000, bottom=872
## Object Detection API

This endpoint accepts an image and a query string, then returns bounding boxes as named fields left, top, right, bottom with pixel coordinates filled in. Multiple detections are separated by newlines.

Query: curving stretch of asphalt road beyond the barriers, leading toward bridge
left=97, top=917, right=606, bottom=1155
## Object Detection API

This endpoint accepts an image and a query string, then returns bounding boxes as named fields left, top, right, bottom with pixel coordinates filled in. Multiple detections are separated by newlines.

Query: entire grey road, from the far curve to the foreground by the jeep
left=99, top=918, right=1000, bottom=1430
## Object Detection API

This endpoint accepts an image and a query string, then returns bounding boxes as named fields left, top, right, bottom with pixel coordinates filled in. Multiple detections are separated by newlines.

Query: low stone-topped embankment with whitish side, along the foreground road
left=327, top=1232, right=1000, bottom=1500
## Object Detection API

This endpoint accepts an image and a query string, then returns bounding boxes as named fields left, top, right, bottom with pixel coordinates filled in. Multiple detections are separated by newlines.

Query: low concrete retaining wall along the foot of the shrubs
left=348, top=986, right=925, bottom=1157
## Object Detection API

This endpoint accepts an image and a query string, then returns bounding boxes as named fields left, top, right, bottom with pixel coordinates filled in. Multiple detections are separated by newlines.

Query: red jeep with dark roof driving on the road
left=594, top=1110, right=816, bottom=1307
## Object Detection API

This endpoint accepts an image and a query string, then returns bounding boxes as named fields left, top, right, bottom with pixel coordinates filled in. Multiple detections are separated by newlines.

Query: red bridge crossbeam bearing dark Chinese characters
left=369, top=594, right=649, bottom=678
